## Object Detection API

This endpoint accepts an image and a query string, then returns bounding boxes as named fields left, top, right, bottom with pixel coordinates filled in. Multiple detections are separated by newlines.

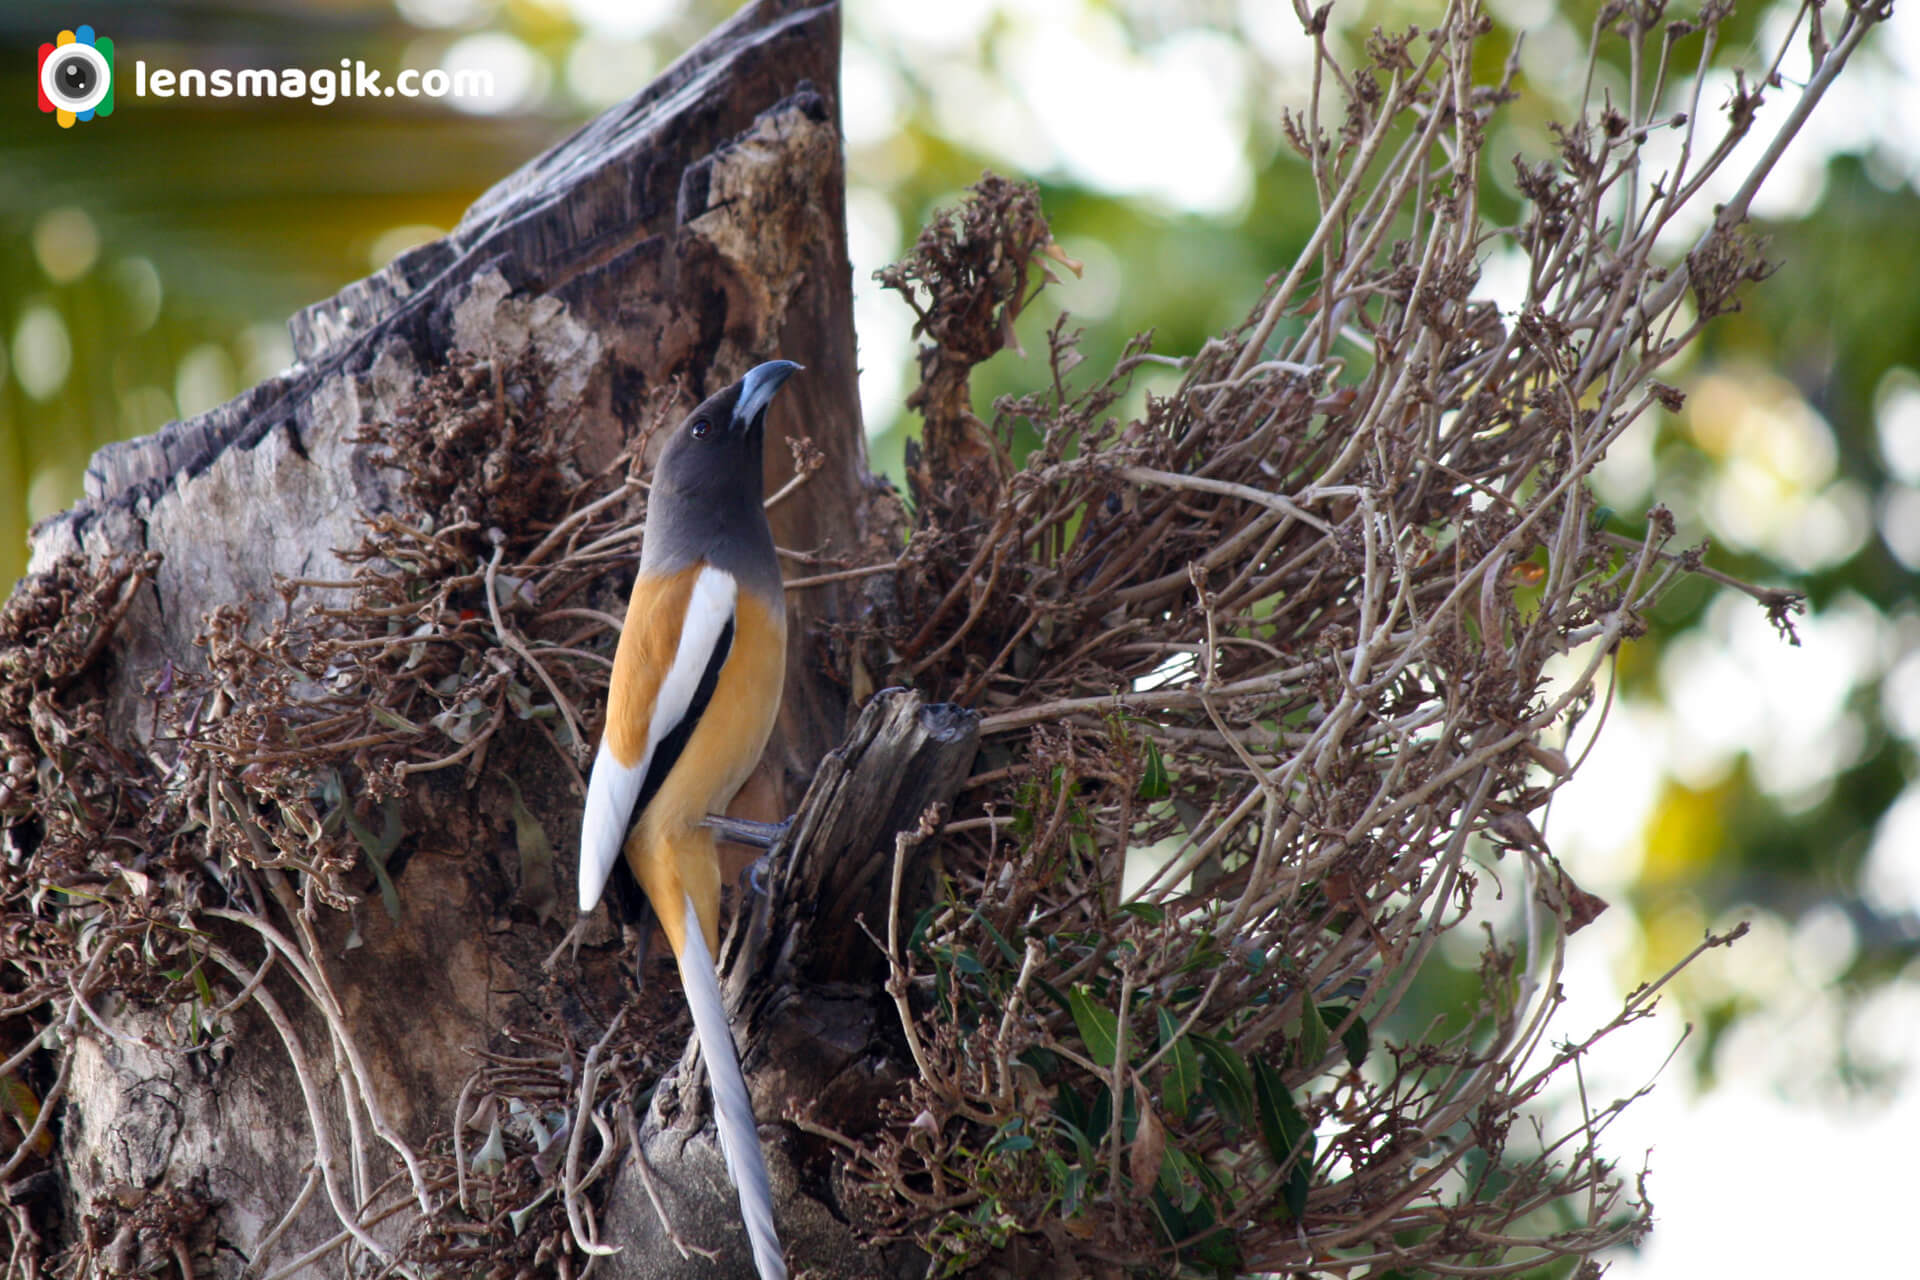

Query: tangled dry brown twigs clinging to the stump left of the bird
left=0, top=345, right=714, bottom=1276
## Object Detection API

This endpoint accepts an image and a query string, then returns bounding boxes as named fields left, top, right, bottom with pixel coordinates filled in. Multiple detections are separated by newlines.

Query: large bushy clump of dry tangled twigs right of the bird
left=803, top=4, right=1882, bottom=1274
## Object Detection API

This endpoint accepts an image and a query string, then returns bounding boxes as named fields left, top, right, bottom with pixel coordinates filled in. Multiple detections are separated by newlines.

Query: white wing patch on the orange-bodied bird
left=580, top=564, right=739, bottom=912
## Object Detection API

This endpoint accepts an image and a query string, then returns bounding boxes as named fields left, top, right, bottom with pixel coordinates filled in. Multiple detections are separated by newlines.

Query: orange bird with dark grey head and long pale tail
left=580, top=361, right=801, bottom=1280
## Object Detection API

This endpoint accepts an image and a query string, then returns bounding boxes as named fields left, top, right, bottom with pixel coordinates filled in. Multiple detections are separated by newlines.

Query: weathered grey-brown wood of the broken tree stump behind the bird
left=35, top=0, right=956, bottom=1276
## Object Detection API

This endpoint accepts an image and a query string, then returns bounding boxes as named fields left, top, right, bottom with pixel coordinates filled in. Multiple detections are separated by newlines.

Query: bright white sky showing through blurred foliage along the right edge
left=1512, top=6, right=1920, bottom=1258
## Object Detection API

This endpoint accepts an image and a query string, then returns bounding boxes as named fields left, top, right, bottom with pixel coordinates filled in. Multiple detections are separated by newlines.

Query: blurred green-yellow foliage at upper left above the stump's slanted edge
left=0, top=4, right=576, bottom=581
